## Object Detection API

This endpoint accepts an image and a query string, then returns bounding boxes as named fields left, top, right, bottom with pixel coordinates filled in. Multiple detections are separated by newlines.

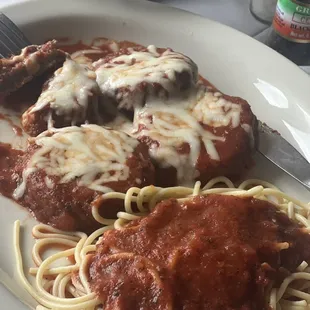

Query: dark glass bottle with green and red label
left=266, top=0, right=310, bottom=66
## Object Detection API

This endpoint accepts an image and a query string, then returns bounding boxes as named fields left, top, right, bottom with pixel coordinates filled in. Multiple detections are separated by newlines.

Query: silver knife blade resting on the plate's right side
left=258, top=121, right=310, bottom=191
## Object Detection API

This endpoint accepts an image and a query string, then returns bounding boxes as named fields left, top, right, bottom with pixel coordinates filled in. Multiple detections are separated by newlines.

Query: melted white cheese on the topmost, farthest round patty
left=94, top=45, right=197, bottom=105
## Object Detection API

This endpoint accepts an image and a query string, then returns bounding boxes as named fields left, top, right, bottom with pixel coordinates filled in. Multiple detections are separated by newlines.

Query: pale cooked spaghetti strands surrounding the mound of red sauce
left=14, top=177, right=310, bottom=310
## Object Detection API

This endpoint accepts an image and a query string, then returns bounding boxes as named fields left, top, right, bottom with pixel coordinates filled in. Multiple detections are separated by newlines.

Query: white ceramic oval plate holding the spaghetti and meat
left=0, top=0, right=310, bottom=310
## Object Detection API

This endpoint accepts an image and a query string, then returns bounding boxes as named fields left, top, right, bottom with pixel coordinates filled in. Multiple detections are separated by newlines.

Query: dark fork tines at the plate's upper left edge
left=0, top=12, right=31, bottom=58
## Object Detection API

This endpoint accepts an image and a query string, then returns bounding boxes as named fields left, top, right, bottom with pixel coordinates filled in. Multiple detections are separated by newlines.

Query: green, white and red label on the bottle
left=273, top=0, right=310, bottom=43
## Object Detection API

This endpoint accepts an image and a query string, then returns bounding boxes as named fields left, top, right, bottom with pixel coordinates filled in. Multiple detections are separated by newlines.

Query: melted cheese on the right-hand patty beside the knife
left=130, top=85, right=242, bottom=185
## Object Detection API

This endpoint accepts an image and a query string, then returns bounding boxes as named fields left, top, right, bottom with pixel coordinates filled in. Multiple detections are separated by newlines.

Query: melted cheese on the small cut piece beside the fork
left=29, top=59, right=98, bottom=125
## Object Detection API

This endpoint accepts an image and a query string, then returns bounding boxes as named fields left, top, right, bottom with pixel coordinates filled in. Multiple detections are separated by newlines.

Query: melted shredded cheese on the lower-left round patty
left=14, top=125, right=138, bottom=199
